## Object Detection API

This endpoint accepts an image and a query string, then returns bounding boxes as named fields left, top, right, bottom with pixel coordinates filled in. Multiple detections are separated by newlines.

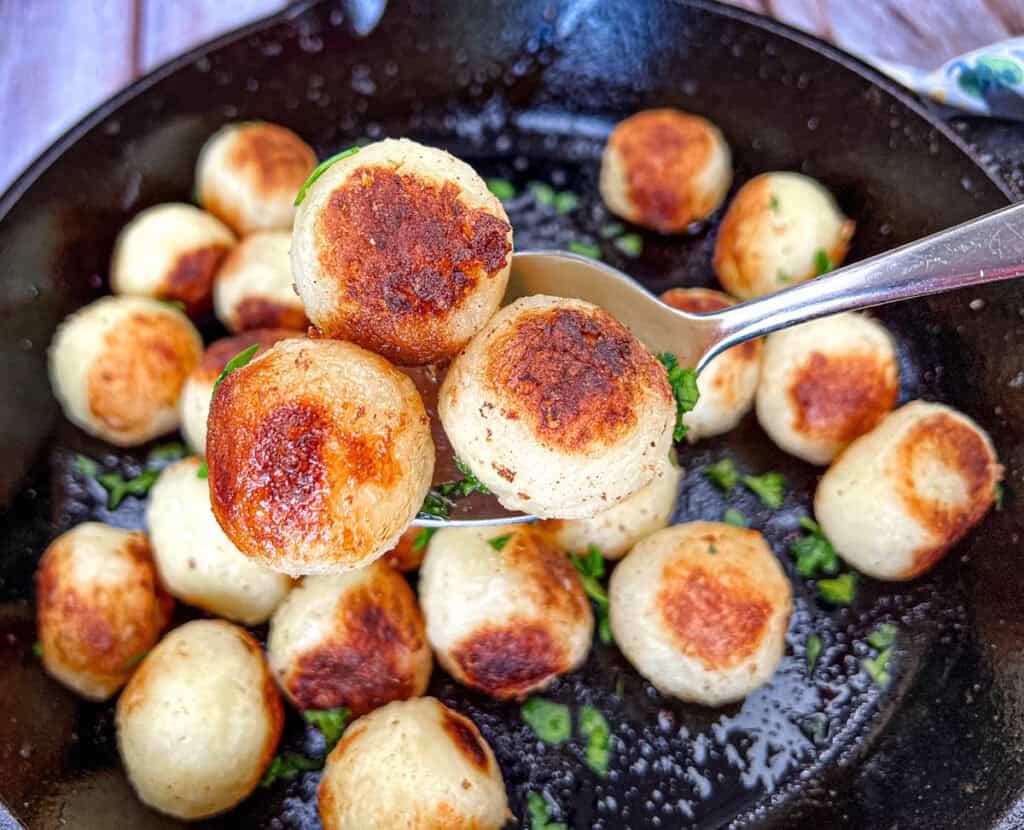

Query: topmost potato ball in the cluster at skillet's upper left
left=196, top=121, right=316, bottom=235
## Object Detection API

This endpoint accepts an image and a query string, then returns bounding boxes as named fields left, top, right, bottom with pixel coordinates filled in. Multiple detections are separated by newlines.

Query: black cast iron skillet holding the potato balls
left=0, top=0, right=1024, bottom=830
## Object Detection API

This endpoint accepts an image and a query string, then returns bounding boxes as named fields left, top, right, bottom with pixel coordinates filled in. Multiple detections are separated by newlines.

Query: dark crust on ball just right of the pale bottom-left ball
left=288, top=568, right=426, bottom=715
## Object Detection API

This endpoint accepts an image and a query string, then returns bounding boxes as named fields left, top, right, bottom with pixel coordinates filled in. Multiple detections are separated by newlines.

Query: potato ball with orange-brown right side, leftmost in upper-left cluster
left=49, top=297, right=203, bottom=446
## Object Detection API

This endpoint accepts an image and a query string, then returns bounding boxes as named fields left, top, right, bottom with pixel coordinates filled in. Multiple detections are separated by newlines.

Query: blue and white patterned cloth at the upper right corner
left=871, top=38, right=1024, bottom=121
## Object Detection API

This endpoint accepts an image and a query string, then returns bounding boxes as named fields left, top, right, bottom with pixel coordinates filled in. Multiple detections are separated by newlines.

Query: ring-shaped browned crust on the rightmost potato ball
left=893, top=412, right=1002, bottom=578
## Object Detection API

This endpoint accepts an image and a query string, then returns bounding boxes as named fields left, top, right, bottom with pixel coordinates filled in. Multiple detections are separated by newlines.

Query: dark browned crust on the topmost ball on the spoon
left=317, top=167, right=511, bottom=363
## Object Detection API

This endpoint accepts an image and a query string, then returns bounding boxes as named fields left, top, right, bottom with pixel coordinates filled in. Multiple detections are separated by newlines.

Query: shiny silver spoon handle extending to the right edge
left=698, top=203, right=1024, bottom=368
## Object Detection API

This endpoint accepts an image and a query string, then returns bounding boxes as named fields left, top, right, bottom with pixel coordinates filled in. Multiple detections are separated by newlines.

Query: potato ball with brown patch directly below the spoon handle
left=757, top=313, right=899, bottom=465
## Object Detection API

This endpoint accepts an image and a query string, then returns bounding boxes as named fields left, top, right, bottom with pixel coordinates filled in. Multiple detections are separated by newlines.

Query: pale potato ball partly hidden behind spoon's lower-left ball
left=145, top=457, right=292, bottom=625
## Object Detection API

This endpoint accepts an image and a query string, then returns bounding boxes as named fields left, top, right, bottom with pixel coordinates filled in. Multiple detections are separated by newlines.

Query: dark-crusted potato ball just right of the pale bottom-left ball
left=267, top=560, right=433, bottom=715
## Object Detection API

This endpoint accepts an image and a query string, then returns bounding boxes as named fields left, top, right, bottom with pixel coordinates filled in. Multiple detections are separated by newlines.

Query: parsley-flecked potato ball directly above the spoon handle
left=715, top=173, right=854, bottom=300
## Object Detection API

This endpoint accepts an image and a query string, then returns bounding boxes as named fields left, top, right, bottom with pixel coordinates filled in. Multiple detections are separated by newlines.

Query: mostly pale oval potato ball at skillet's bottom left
left=116, top=619, right=284, bottom=819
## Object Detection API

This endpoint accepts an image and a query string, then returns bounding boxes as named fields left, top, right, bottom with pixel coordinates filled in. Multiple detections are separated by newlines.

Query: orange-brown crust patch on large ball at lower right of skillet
left=655, top=562, right=772, bottom=671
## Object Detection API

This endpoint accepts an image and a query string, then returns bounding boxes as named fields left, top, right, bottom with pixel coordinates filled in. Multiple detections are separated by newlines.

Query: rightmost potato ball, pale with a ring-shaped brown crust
left=814, top=400, right=1002, bottom=580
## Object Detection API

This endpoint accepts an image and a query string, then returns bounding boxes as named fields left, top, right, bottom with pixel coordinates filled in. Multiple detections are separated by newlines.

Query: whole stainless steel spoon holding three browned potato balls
left=413, top=197, right=1024, bottom=527
